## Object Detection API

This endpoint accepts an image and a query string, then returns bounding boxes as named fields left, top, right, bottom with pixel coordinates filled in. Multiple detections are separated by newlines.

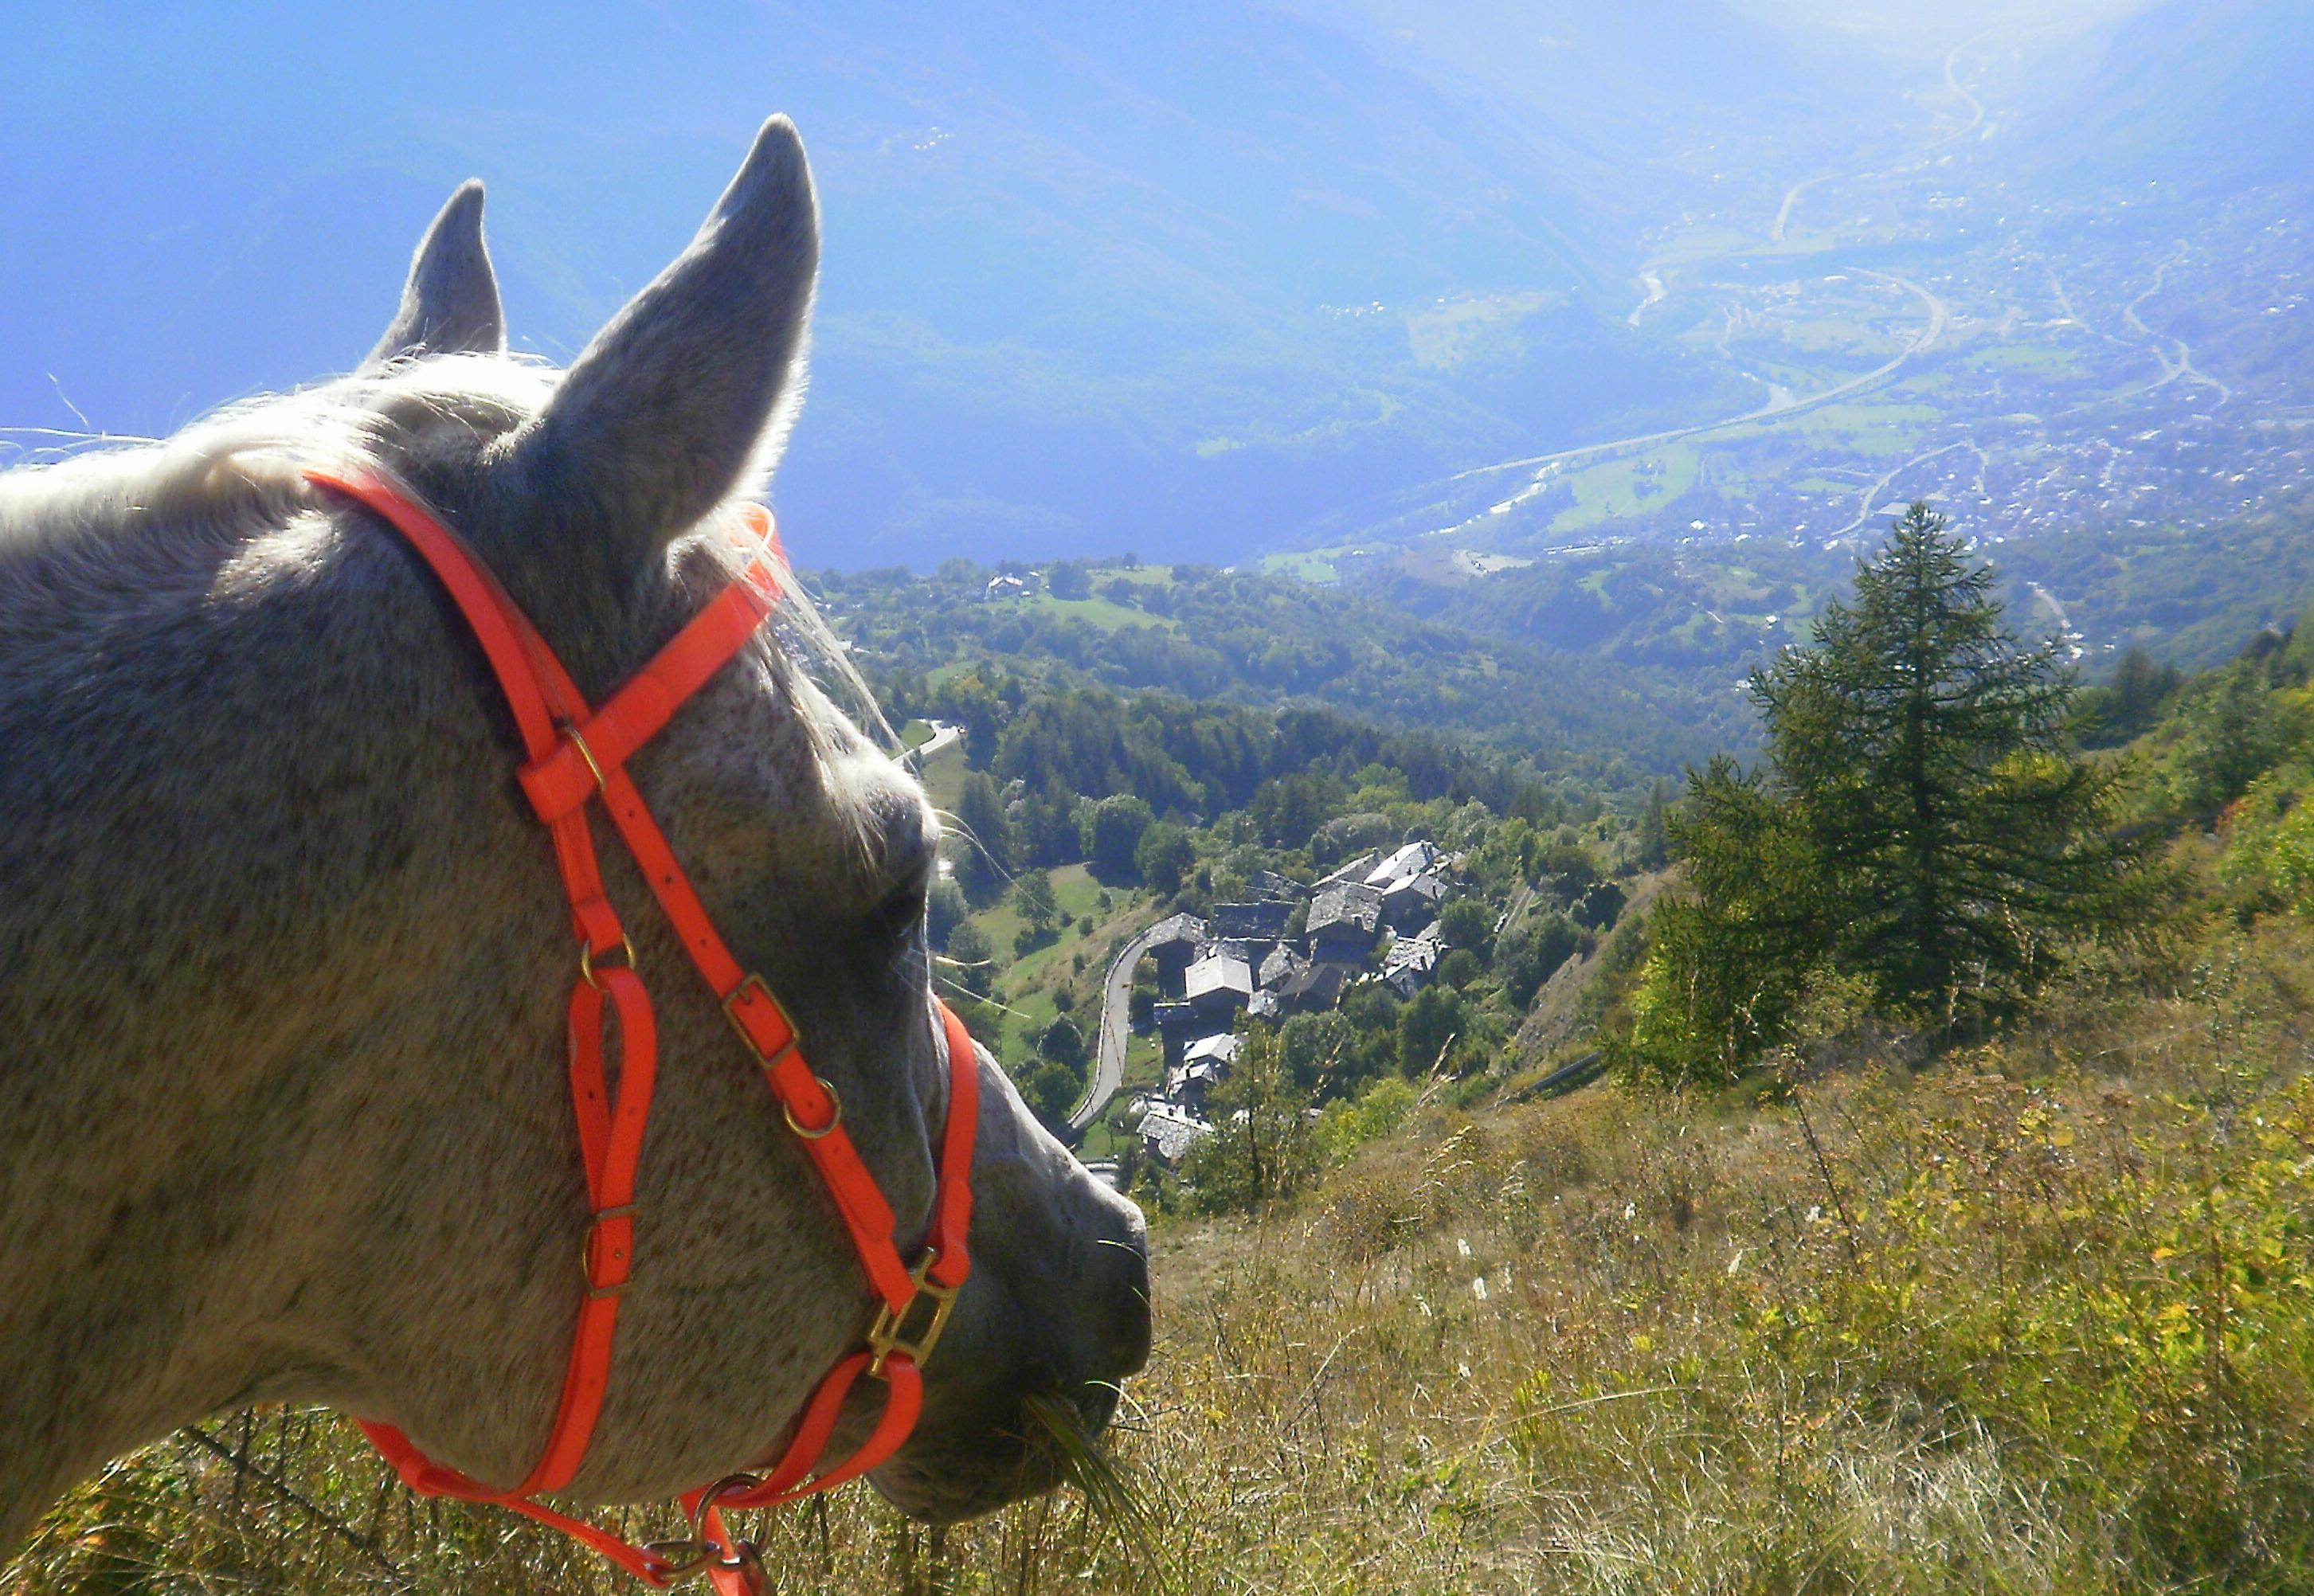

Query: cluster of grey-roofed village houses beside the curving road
left=1134, top=842, right=1451, bottom=1164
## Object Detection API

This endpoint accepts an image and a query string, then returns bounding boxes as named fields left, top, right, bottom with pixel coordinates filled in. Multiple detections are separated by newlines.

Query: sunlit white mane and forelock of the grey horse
left=0, top=354, right=900, bottom=849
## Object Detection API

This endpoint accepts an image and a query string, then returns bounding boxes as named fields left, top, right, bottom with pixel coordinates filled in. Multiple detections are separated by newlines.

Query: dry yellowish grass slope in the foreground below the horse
left=10, top=928, right=2314, bottom=1594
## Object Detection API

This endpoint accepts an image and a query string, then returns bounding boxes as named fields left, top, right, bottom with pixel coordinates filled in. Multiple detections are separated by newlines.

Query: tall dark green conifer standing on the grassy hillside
left=1752, top=504, right=2127, bottom=1011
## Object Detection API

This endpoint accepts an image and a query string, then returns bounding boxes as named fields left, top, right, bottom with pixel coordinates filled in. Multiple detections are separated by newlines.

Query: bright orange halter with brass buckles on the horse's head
left=305, top=470, right=979, bottom=1596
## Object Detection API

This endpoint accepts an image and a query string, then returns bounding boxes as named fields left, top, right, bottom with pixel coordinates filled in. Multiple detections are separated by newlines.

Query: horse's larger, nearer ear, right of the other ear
left=514, top=115, right=819, bottom=562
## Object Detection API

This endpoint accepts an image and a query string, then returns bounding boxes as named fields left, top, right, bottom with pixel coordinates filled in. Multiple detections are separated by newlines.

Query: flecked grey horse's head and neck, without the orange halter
left=0, top=118, right=1148, bottom=1547
